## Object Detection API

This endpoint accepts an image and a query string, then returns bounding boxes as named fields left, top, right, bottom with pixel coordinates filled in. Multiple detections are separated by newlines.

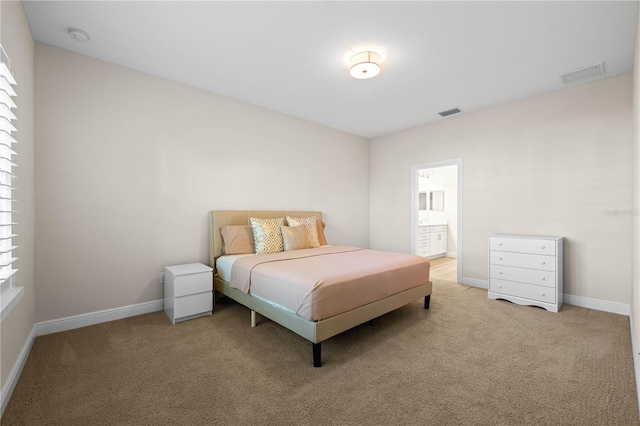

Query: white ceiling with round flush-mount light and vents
left=23, top=1, right=638, bottom=138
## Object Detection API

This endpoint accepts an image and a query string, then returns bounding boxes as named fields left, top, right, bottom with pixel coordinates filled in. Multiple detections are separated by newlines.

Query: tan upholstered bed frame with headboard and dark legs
left=209, top=210, right=432, bottom=367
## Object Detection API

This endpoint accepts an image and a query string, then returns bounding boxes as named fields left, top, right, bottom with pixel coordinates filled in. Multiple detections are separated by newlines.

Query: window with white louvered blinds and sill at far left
left=0, top=46, right=24, bottom=321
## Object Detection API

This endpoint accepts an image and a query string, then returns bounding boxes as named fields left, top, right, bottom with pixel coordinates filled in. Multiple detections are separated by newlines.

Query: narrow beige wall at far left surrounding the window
left=0, top=1, right=35, bottom=388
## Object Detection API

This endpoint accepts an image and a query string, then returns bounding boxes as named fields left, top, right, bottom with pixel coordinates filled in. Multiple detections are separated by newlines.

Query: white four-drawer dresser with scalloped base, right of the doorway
left=489, top=234, right=563, bottom=312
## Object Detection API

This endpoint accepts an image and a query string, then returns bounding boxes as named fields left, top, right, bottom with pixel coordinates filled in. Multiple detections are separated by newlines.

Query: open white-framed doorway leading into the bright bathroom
left=411, top=158, right=462, bottom=282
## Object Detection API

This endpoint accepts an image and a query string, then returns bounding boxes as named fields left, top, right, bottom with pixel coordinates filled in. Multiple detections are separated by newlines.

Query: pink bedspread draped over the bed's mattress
left=230, top=246, right=429, bottom=321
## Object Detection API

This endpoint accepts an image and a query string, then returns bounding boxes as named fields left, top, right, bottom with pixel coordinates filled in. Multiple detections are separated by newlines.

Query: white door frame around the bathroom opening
left=411, top=158, right=463, bottom=283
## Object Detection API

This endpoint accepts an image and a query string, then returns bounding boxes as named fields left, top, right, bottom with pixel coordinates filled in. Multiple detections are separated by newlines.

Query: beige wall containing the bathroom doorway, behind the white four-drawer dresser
left=370, top=74, right=633, bottom=305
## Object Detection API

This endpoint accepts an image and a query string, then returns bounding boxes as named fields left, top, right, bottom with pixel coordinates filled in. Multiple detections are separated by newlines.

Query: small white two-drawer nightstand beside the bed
left=164, top=263, right=213, bottom=324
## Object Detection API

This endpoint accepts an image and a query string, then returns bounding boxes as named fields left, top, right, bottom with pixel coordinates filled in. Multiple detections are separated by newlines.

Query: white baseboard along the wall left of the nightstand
left=36, top=299, right=164, bottom=336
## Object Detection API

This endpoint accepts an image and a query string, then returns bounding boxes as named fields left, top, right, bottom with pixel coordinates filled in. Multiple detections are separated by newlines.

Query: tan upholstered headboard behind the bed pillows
left=209, top=210, right=322, bottom=272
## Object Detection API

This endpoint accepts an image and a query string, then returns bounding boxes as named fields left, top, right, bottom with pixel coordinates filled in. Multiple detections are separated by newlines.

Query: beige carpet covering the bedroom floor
left=2, top=281, right=639, bottom=426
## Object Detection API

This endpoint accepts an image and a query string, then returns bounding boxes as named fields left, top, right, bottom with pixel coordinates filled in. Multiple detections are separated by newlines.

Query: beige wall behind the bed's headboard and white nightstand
left=36, top=43, right=369, bottom=321
